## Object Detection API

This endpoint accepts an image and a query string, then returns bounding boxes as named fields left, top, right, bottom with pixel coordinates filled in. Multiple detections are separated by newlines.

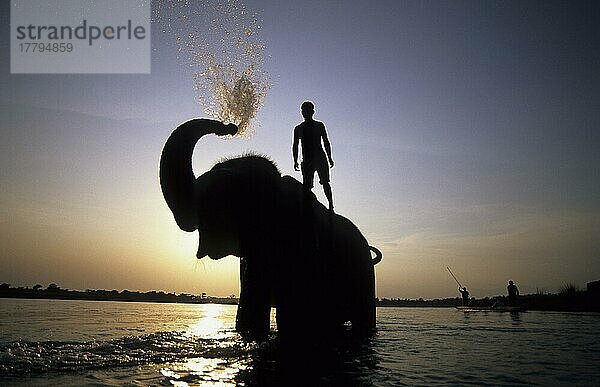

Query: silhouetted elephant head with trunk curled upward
left=160, top=119, right=280, bottom=259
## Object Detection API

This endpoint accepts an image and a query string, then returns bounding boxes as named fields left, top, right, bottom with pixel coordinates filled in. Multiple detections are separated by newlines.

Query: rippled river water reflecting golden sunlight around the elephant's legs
left=0, top=299, right=600, bottom=386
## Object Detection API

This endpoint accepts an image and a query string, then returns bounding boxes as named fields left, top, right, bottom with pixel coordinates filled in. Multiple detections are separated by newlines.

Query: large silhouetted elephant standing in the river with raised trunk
left=159, top=118, right=382, bottom=338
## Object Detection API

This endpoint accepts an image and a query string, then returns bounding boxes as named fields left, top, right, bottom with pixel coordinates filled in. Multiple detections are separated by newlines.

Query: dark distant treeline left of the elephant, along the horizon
left=0, top=283, right=238, bottom=304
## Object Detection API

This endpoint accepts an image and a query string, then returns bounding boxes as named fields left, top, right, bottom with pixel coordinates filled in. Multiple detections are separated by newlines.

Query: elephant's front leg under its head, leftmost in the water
left=235, top=259, right=271, bottom=339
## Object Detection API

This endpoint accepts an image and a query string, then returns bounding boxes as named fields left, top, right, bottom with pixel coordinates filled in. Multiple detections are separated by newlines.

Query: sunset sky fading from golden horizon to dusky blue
left=0, top=0, right=600, bottom=298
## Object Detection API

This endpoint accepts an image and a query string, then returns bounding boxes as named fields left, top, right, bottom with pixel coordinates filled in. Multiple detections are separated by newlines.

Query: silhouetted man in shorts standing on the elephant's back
left=292, top=101, right=333, bottom=211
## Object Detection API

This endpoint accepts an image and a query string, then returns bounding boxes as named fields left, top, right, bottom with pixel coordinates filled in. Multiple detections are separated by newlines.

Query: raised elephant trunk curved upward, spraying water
left=159, top=118, right=238, bottom=232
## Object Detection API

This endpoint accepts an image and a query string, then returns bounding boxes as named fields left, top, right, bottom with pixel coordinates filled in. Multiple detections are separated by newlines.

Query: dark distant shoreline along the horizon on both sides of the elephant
left=0, top=284, right=600, bottom=312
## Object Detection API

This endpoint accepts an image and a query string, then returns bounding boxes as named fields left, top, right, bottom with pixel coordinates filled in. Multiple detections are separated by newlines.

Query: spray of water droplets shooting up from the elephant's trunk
left=153, top=0, right=270, bottom=136
